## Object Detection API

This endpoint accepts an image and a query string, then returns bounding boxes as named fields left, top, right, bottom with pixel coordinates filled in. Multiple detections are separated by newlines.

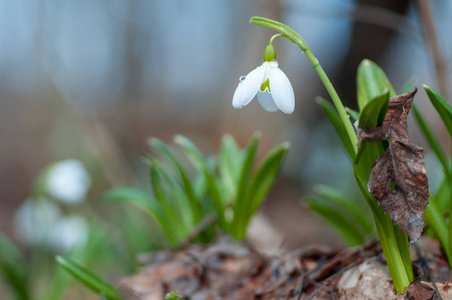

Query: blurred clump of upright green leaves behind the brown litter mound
left=104, top=134, right=288, bottom=248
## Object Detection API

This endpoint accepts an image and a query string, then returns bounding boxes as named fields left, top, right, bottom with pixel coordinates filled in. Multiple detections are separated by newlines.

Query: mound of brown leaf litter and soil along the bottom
left=120, top=237, right=452, bottom=300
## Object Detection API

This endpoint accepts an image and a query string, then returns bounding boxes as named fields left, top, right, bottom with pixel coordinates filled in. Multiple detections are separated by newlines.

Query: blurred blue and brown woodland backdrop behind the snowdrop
left=0, top=0, right=452, bottom=298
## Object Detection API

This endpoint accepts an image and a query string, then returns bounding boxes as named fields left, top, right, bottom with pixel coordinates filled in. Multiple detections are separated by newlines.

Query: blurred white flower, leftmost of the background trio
left=14, top=199, right=61, bottom=245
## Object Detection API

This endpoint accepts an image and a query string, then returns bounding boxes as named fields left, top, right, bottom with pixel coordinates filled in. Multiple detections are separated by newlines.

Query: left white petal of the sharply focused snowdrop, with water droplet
left=232, top=66, right=265, bottom=108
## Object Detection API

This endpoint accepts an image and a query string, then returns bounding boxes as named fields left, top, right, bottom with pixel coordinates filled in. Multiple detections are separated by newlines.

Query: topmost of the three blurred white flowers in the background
left=47, top=159, right=91, bottom=203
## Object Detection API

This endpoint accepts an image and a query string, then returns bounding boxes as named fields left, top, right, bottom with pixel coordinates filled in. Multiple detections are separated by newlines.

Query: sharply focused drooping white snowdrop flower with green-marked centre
left=232, top=45, right=295, bottom=114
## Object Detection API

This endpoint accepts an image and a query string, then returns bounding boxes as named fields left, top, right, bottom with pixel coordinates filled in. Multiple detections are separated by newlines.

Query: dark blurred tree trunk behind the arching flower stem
left=332, top=0, right=411, bottom=108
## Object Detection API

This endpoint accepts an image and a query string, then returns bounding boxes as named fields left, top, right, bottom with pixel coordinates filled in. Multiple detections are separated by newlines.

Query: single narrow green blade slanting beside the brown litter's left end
left=56, top=256, right=122, bottom=300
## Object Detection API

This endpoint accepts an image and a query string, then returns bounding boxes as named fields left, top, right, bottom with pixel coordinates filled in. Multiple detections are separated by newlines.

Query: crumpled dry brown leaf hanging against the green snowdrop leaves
left=358, top=89, right=429, bottom=243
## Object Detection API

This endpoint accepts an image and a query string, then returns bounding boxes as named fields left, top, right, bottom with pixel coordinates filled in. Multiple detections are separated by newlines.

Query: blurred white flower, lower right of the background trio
left=49, top=215, right=89, bottom=252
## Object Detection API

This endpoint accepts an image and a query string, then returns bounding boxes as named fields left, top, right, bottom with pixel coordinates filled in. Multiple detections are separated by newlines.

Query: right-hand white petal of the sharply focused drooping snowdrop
left=269, top=68, right=295, bottom=114
